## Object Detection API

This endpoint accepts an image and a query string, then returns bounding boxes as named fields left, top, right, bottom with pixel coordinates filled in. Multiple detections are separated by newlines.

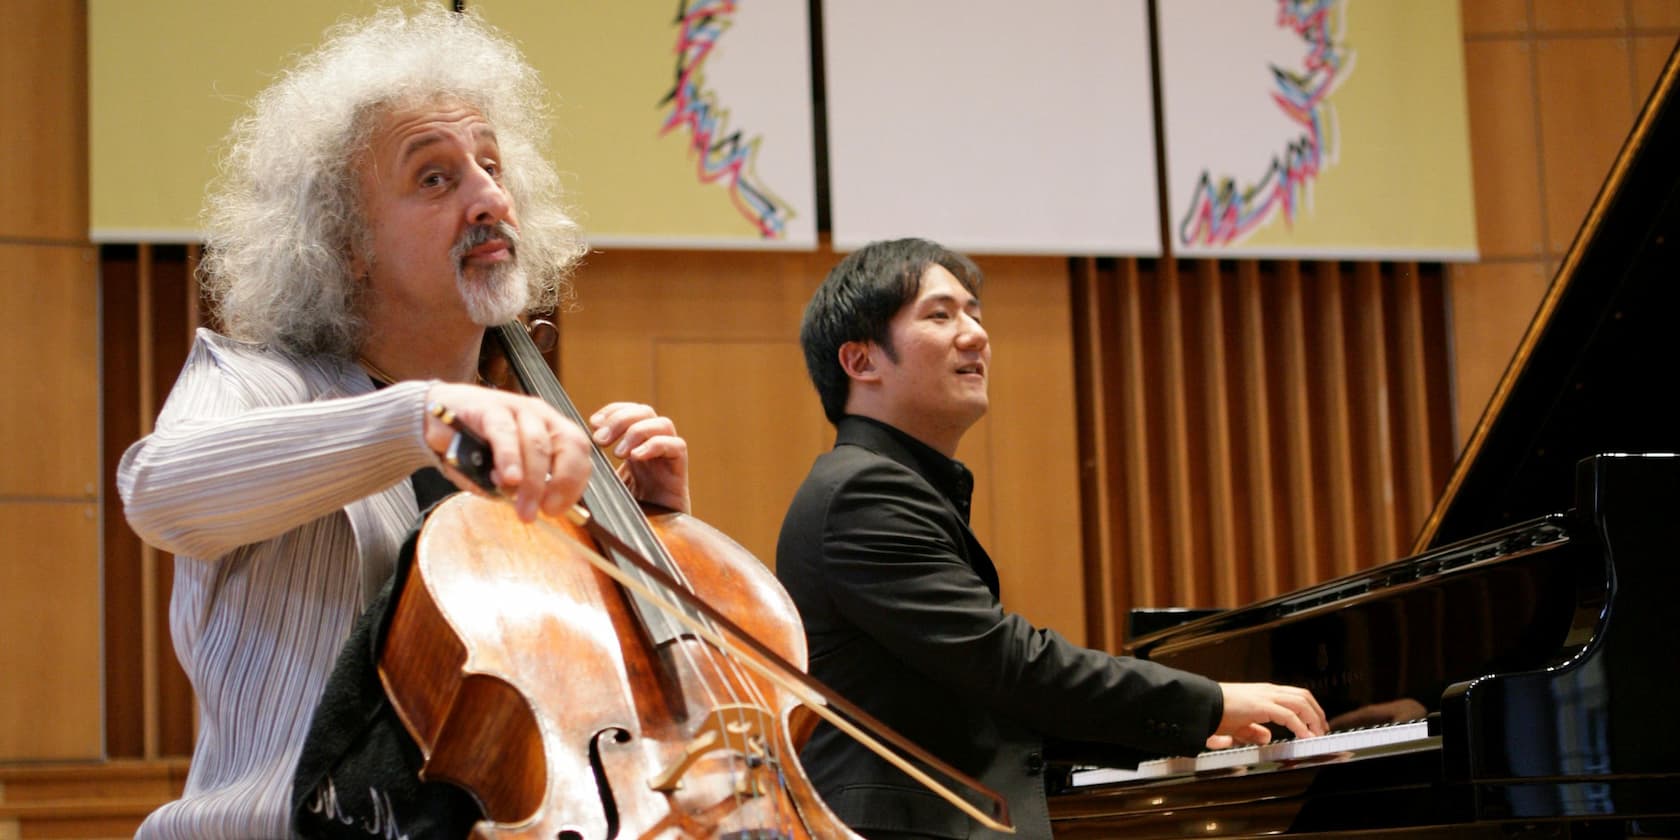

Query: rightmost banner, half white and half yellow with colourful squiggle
left=1158, top=0, right=1477, bottom=260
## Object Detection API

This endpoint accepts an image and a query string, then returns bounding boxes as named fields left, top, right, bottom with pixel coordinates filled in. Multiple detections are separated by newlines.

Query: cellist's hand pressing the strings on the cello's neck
left=590, top=403, right=689, bottom=512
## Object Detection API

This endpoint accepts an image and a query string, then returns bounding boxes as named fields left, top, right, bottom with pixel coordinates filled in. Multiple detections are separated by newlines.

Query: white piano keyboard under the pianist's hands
left=1068, top=721, right=1430, bottom=788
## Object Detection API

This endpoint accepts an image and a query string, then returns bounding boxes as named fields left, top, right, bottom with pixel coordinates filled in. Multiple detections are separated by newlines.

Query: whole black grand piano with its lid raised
left=1050, top=40, right=1680, bottom=838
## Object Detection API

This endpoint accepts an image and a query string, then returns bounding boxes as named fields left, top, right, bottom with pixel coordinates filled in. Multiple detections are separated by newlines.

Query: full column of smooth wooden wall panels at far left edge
left=0, top=0, right=104, bottom=761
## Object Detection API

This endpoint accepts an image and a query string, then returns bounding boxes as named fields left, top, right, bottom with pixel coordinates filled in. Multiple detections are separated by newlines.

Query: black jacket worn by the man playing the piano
left=776, top=417, right=1223, bottom=837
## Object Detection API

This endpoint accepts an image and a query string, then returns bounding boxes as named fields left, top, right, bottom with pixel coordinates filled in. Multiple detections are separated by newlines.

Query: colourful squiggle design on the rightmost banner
left=1178, top=0, right=1352, bottom=245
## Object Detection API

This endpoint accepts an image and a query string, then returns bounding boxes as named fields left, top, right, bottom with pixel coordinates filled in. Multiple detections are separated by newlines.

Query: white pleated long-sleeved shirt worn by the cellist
left=118, top=329, right=437, bottom=840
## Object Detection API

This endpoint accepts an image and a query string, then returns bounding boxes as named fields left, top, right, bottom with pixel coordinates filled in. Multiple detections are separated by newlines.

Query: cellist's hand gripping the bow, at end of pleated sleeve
left=425, top=383, right=591, bottom=522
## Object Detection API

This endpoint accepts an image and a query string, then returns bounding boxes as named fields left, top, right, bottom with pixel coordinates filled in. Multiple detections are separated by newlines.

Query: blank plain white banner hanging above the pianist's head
left=823, top=0, right=1171, bottom=255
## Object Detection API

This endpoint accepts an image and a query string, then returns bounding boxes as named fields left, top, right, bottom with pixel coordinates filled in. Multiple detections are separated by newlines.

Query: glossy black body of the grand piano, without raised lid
left=1052, top=455, right=1680, bottom=837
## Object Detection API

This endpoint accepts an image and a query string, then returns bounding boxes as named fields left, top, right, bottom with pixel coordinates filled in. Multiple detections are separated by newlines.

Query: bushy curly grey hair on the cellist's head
left=200, top=5, right=585, bottom=358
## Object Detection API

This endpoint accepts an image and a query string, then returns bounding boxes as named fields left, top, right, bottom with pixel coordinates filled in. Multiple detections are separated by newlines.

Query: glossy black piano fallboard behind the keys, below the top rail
left=1132, top=514, right=1585, bottom=729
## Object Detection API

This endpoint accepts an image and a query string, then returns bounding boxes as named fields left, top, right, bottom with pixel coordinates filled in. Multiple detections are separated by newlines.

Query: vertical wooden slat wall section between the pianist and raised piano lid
left=1072, top=259, right=1453, bottom=647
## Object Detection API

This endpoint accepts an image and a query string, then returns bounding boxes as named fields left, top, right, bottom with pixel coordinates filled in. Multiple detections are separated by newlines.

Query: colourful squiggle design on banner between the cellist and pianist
left=659, top=0, right=793, bottom=239
